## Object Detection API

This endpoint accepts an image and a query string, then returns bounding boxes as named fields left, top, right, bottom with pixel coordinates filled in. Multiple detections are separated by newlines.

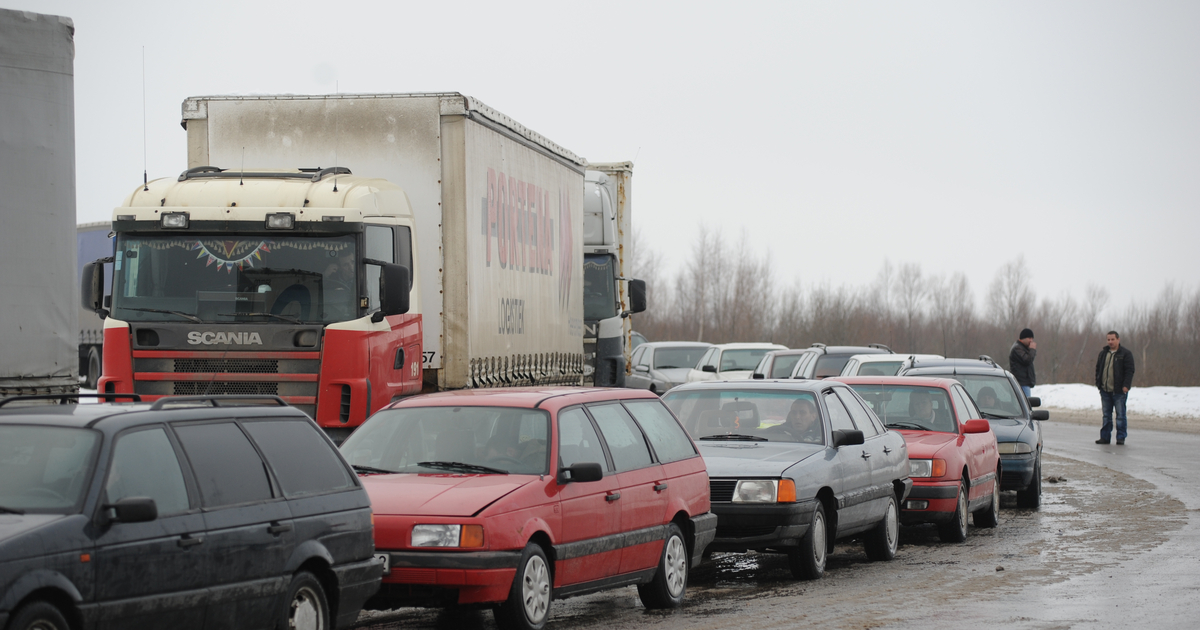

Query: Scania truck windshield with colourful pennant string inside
left=113, top=235, right=359, bottom=323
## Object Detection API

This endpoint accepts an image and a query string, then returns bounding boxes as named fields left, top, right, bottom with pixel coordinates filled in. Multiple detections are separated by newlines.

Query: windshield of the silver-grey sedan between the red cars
left=662, top=389, right=824, bottom=444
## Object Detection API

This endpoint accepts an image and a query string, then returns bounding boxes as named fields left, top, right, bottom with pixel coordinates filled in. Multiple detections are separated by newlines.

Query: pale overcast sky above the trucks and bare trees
left=11, top=0, right=1200, bottom=313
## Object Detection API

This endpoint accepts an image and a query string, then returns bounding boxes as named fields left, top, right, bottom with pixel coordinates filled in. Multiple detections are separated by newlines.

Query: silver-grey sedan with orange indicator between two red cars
left=662, top=379, right=912, bottom=580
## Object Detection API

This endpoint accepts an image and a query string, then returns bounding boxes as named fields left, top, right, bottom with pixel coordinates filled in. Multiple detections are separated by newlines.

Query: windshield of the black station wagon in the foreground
left=0, top=425, right=100, bottom=514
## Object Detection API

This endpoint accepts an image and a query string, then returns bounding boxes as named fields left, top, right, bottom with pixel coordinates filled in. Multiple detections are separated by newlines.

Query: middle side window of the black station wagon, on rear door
left=174, top=422, right=272, bottom=508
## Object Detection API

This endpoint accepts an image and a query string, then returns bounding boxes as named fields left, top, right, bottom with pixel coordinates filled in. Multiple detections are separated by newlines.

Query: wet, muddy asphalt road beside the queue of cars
left=360, top=421, right=1200, bottom=630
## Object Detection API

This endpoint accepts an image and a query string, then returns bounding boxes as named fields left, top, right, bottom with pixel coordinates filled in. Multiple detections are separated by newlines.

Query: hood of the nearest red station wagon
left=362, top=474, right=536, bottom=516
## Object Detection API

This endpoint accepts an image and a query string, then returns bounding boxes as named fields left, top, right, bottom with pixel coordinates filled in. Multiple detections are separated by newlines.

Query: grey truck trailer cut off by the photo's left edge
left=0, top=8, right=79, bottom=397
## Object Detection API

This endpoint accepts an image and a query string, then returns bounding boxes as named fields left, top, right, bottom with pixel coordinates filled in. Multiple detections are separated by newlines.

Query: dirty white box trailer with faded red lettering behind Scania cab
left=182, top=94, right=587, bottom=389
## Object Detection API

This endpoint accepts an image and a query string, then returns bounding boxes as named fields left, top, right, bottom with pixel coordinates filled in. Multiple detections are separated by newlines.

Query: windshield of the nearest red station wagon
left=342, top=407, right=550, bottom=475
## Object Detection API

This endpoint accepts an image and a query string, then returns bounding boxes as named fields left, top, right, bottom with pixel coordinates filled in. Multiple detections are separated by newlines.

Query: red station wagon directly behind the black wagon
left=342, top=388, right=716, bottom=629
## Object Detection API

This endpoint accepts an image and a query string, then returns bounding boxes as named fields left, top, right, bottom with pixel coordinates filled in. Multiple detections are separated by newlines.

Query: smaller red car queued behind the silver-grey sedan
left=835, top=377, right=1000, bottom=542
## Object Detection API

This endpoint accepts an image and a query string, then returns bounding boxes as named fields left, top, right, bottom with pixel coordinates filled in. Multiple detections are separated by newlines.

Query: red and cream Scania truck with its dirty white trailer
left=84, top=94, right=587, bottom=439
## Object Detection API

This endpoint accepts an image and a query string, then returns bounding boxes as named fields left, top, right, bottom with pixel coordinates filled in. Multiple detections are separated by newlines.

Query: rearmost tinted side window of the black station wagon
left=244, top=420, right=354, bottom=498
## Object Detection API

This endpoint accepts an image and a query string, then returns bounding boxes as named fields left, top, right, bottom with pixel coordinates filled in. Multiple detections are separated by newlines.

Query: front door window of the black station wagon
left=104, top=427, right=190, bottom=516
